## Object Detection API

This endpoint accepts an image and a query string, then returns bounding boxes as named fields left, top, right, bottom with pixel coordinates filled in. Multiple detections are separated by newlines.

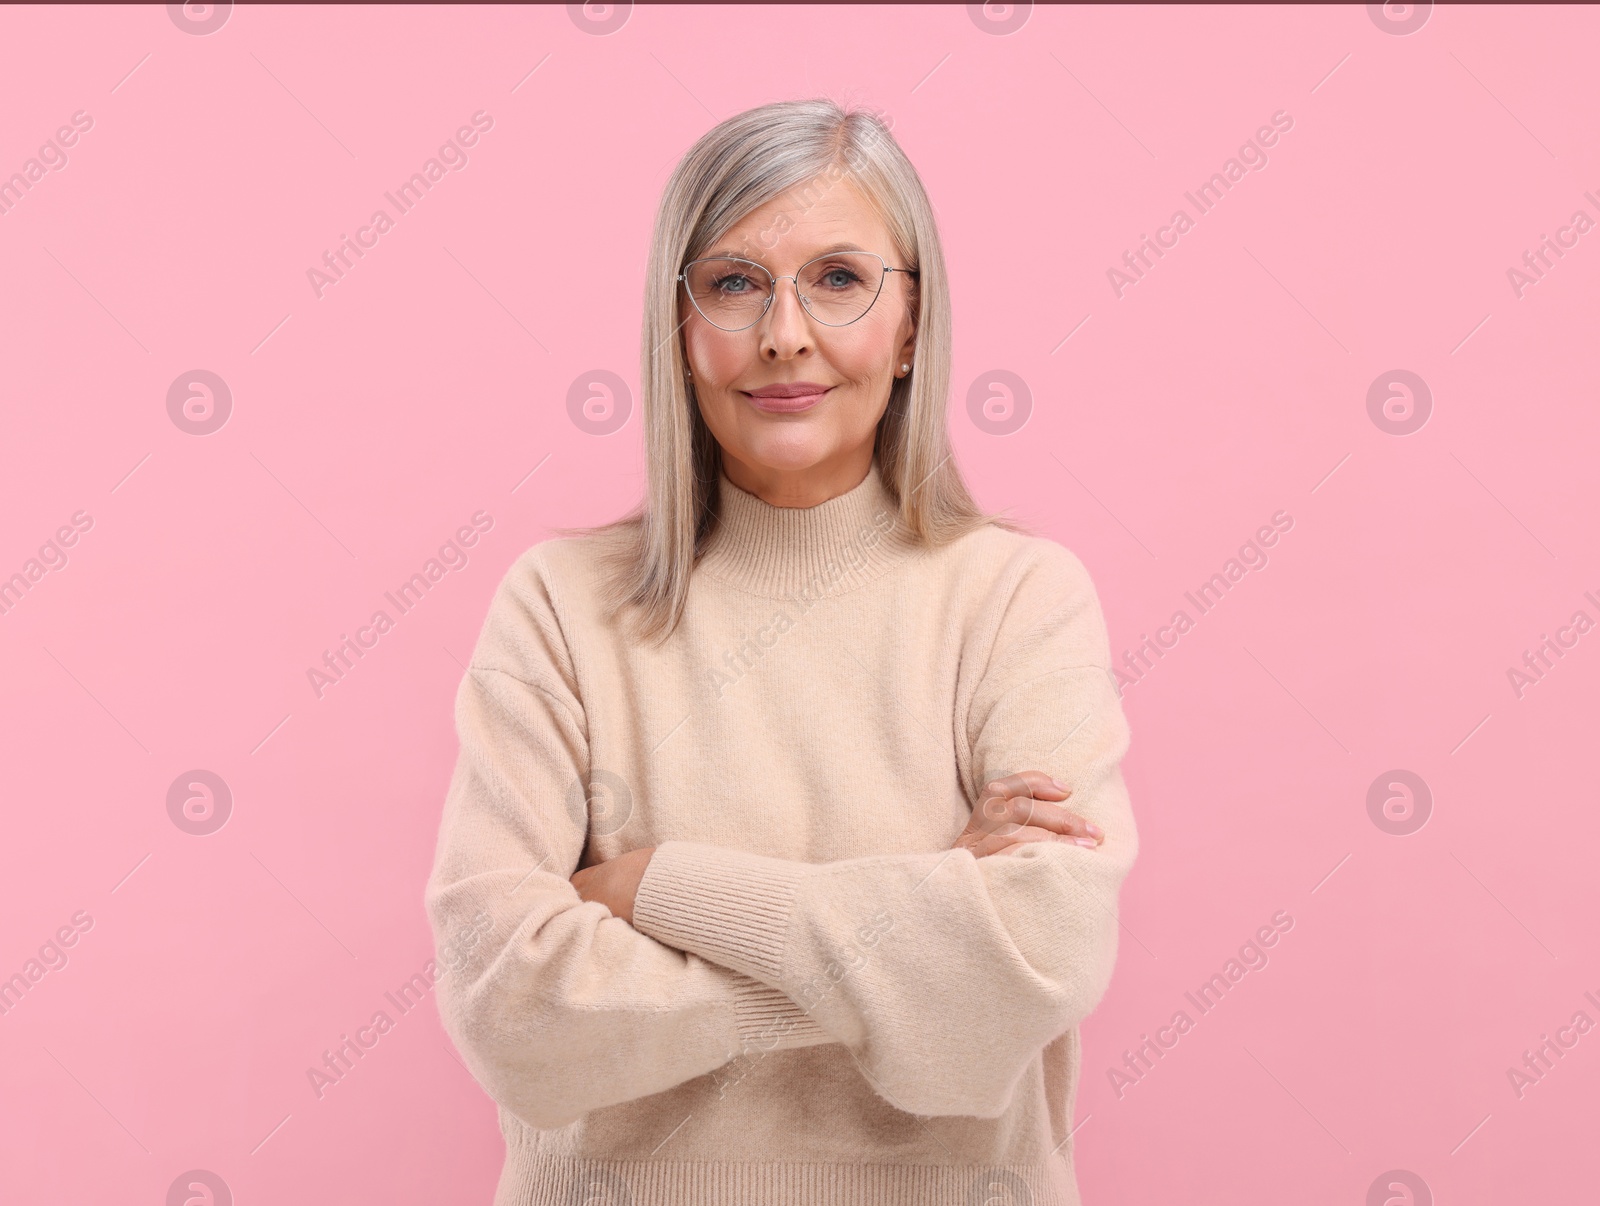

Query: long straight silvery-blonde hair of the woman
left=557, top=98, right=1026, bottom=638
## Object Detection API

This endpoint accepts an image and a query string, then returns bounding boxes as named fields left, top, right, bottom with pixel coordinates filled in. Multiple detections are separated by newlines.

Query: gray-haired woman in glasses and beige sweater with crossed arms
left=426, top=101, right=1138, bottom=1206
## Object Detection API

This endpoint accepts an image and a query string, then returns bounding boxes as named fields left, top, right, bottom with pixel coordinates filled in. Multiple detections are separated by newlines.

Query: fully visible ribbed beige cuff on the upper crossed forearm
left=634, top=841, right=808, bottom=988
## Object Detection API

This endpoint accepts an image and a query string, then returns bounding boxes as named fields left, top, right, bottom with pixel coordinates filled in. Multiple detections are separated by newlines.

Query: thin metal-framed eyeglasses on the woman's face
left=678, top=251, right=917, bottom=331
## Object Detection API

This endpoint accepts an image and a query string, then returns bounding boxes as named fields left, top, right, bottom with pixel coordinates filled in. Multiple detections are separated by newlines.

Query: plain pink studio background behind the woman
left=0, top=5, right=1600, bottom=1206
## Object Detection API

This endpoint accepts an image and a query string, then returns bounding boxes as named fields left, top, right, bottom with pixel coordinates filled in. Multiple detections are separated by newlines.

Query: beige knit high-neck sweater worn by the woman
left=426, top=464, right=1138, bottom=1206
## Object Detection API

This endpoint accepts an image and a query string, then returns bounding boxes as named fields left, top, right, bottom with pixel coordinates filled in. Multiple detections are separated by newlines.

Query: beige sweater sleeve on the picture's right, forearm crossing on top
left=634, top=537, right=1138, bottom=1118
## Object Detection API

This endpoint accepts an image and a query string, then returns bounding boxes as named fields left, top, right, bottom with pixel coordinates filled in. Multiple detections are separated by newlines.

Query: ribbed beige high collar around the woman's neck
left=698, top=459, right=915, bottom=601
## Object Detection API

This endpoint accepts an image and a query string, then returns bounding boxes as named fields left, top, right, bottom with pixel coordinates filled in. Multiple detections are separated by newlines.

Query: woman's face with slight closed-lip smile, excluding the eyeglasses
left=678, top=178, right=917, bottom=505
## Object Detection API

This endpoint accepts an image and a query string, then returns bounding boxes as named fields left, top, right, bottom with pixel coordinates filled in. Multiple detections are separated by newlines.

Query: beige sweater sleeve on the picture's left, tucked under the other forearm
left=424, top=550, right=834, bottom=1128
